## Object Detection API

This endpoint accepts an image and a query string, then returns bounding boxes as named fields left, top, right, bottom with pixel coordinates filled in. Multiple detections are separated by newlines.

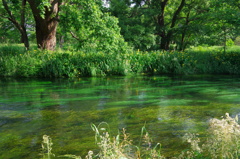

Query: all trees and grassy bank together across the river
left=0, top=0, right=240, bottom=77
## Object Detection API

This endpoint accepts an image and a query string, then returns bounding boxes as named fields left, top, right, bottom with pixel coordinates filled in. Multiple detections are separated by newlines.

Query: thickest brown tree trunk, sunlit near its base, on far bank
left=27, top=0, right=61, bottom=50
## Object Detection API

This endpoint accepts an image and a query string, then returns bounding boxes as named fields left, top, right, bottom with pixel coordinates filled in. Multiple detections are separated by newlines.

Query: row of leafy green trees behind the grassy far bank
left=0, top=0, right=240, bottom=53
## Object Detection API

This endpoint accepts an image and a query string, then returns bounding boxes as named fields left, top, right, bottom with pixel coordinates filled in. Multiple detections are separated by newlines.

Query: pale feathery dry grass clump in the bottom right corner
left=179, top=113, right=240, bottom=159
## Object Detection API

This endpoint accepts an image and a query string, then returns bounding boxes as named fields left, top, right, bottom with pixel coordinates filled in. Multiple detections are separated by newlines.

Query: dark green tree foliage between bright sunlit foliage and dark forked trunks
left=108, top=0, right=156, bottom=50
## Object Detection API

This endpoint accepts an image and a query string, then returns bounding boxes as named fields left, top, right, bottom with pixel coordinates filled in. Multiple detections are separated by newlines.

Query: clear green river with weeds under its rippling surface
left=0, top=76, right=240, bottom=158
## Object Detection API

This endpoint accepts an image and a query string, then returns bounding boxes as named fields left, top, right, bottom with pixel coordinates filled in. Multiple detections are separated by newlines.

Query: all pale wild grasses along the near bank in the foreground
left=42, top=113, right=240, bottom=159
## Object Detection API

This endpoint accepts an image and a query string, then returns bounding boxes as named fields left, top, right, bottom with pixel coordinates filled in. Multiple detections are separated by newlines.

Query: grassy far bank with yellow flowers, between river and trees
left=0, top=45, right=240, bottom=77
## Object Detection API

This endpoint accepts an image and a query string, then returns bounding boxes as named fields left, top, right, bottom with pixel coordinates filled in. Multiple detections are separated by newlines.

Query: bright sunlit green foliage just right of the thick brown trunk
left=60, top=0, right=128, bottom=53
